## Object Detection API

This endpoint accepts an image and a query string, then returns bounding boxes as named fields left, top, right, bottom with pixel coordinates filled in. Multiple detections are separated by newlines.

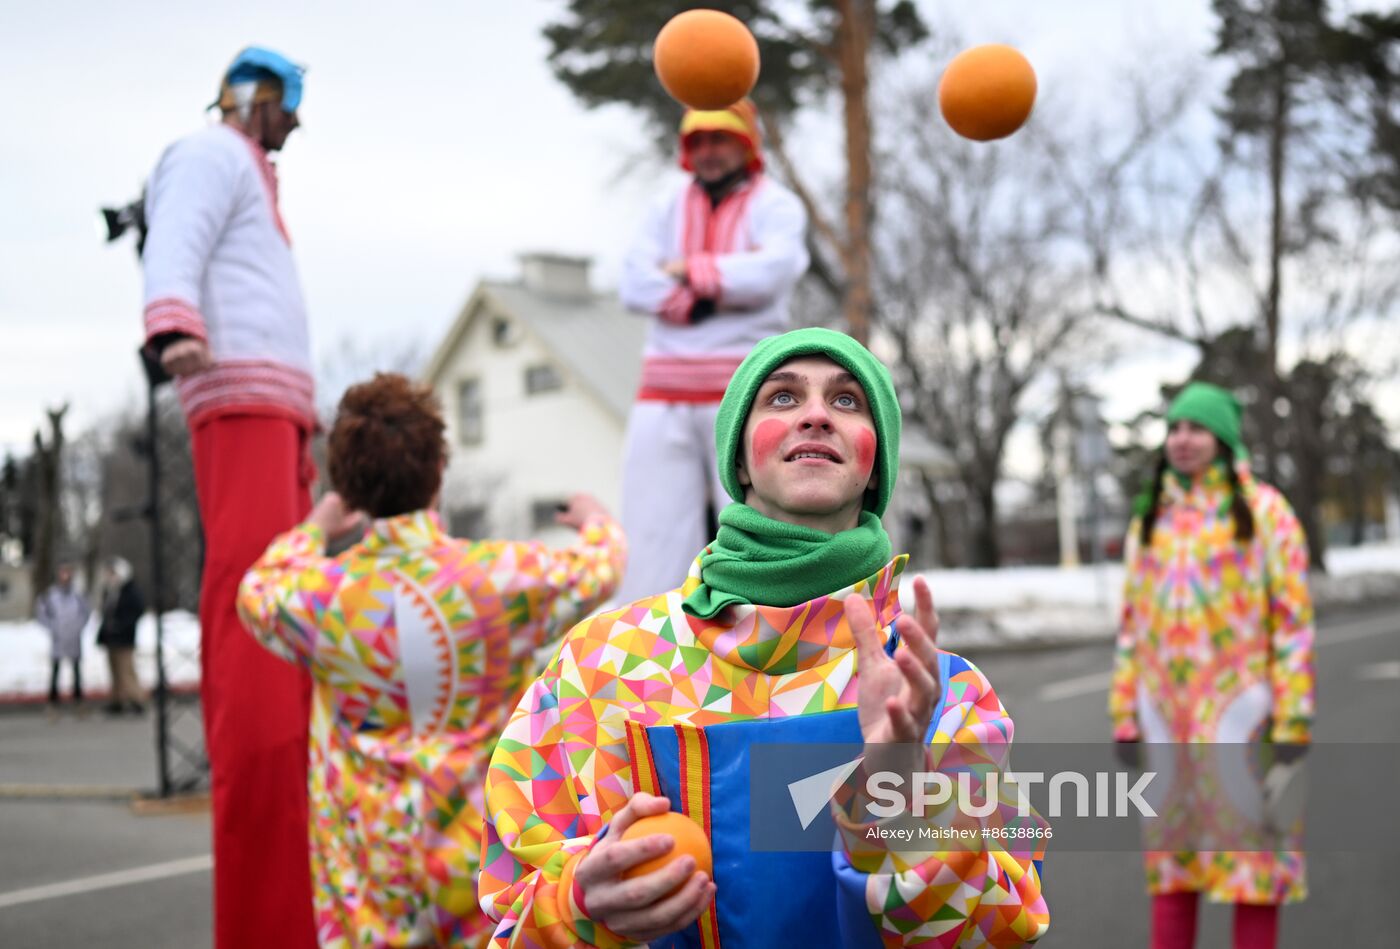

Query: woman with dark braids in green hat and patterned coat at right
left=1109, top=382, right=1313, bottom=949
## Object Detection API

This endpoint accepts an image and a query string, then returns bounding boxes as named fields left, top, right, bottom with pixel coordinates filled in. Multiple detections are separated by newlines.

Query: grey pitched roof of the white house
left=424, top=280, right=647, bottom=420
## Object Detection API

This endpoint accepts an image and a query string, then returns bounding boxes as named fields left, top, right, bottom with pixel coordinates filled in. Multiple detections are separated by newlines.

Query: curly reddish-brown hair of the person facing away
left=329, top=372, right=447, bottom=518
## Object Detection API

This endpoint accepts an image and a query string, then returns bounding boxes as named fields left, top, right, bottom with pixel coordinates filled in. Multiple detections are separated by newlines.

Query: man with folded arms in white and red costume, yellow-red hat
left=619, top=99, right=808, bottom=600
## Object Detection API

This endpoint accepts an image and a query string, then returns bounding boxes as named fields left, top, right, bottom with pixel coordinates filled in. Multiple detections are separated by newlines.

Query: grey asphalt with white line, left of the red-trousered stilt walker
left=0, top=711, right=213, bottom=949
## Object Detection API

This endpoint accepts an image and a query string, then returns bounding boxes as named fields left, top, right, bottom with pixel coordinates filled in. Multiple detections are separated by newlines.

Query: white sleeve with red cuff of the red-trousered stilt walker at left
left=141, top=134, right=239, bottom=340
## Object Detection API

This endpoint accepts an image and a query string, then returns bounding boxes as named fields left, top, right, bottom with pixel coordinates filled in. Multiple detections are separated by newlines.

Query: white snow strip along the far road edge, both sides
left=0, top=543, right=1400, bottom=701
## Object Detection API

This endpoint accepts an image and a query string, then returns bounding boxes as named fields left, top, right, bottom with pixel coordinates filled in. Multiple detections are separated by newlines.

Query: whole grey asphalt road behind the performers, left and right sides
left=0, top=609, right=1400, bottom=949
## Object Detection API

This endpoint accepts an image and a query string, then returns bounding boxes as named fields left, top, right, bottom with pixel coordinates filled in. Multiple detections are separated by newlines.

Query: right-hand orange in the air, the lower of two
left=938, top=43, right=1036, bottom=141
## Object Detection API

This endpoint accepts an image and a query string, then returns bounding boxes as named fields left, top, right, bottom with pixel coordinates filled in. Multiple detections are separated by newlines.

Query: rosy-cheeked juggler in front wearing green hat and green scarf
left=479, top=329, right=1049, bottom=949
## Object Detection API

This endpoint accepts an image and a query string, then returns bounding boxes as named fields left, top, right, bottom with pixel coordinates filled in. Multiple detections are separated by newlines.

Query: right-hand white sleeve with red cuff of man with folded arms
left=687, top=192, right=809, bottom=309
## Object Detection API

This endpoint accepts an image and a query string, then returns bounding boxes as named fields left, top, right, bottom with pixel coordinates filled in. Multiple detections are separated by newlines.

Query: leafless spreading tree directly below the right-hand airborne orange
left=876, top=70, right=1184, bottom=567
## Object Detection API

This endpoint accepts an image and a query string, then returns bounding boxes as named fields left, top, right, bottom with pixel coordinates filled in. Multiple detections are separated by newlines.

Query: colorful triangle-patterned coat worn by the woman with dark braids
left=1109, top=465, right=1313, bottom=904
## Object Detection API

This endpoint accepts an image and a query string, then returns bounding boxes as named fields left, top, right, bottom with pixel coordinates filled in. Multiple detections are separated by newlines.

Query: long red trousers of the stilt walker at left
left=193, top=416, right=316, bottom=949
